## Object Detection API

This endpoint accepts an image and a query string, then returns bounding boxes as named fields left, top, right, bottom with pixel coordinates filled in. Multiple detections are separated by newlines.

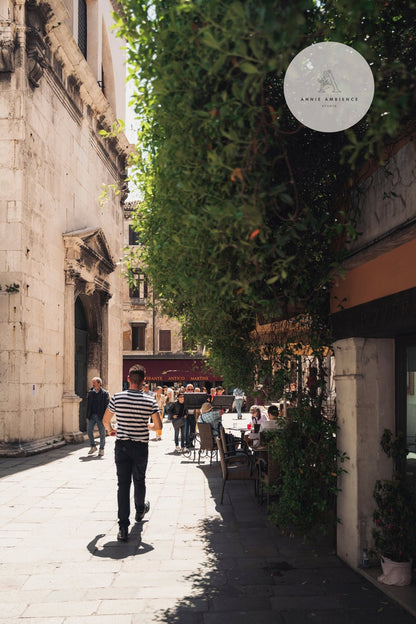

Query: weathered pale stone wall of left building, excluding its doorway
left=0, top=2, right=128, bottom=443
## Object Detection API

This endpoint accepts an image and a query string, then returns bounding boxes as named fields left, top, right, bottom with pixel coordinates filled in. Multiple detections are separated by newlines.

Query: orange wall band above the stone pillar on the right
left=331, top=239, right=416, bottom=313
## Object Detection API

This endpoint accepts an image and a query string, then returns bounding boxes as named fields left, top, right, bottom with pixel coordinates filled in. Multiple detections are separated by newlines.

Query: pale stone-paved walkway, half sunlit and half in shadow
left=0, top=432, right=415, bottom=624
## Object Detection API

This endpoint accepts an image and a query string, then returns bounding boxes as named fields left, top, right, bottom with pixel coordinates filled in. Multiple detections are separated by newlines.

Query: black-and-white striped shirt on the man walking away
left=108, top=390, right=159, bottom=442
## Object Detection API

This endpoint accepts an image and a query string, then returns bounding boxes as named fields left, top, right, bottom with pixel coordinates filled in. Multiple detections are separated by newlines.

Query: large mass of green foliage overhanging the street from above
left=114, top=0, right=416, bottom=391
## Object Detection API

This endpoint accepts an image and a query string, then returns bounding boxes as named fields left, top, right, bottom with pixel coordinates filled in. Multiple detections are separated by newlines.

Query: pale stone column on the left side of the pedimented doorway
left=62, top=271, right=84, bottom=442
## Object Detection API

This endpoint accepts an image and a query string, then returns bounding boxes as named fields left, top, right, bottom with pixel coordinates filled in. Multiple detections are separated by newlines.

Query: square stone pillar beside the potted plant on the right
left=334, top=338, right=395, bottom=568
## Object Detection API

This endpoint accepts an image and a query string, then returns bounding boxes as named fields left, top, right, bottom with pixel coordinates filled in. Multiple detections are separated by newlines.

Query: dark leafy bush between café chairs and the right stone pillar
left=270, top=405, right=347, bottom=536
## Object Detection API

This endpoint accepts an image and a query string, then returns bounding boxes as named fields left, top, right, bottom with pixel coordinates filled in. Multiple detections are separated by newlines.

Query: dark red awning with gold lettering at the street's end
left=123, top=358, right=221, bottom=383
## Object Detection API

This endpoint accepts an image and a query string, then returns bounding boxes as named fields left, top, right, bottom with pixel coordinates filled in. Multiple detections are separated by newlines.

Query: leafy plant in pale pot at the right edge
left=372, top=429, right=416, bottom=585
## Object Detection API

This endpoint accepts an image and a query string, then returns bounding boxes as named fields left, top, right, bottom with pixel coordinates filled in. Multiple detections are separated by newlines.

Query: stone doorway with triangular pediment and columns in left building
left=62, top=228, right=116, bottom=440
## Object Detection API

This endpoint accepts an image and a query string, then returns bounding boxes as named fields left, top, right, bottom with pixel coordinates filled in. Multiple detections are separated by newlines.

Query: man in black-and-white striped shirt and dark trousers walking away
left=103, top=364, right=162, bottom=542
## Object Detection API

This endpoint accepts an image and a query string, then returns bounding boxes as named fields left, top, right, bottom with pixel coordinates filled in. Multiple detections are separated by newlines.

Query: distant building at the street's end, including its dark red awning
left=123, top=202, right=220, bottom=387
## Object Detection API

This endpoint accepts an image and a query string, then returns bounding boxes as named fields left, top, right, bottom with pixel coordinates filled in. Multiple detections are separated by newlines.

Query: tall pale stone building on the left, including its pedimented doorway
left=0, top=0, right=130, bottom=453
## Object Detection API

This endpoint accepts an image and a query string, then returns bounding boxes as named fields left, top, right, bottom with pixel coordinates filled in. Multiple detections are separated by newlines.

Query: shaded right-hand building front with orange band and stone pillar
left=331, top=136, right=416, bottom=568
